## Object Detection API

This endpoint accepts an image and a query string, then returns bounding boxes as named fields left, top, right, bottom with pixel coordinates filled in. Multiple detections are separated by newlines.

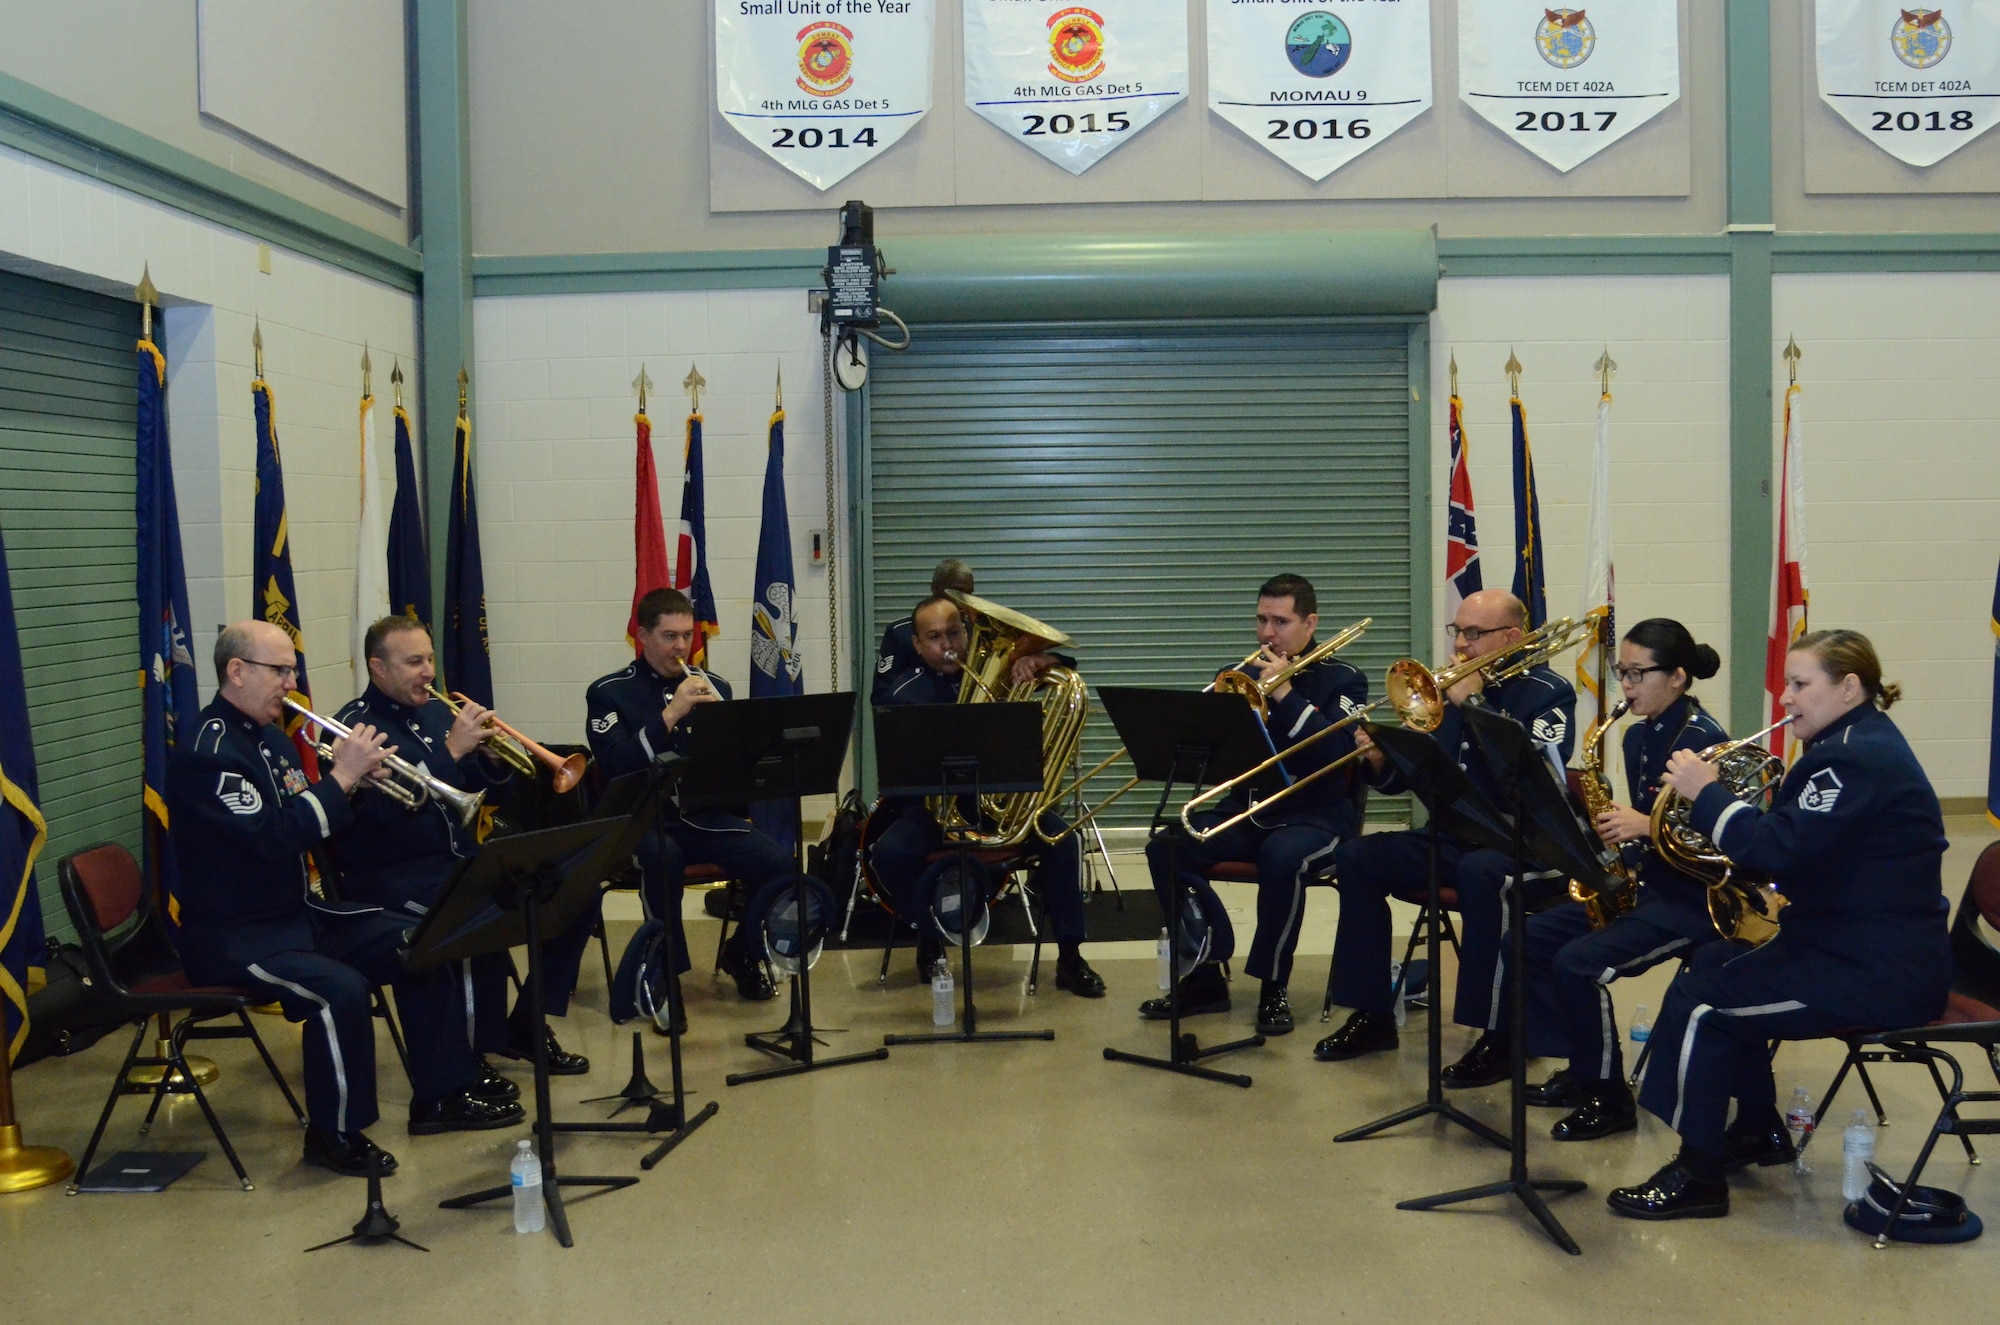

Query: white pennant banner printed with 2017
left=1458, top=0, right=1680, bottom=172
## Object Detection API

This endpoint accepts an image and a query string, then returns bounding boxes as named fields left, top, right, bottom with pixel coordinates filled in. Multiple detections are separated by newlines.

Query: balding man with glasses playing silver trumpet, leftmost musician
left=166, top=620, right=522, bottom=1175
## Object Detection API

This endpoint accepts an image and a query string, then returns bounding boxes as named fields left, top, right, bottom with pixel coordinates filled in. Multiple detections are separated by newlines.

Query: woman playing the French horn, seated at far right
left=1606, top=630, right=1952, bottom=1219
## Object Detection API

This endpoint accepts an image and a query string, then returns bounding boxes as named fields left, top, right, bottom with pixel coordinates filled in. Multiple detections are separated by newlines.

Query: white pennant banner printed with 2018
left=1818, top=0, right=2000, bottom=166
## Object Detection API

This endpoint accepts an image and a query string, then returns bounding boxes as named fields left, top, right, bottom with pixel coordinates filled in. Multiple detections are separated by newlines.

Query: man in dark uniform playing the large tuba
left=870, top=596, right=1104, bottom=999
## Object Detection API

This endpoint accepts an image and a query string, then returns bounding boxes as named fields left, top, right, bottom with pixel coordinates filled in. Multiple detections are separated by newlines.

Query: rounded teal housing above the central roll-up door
left=878, top=230, right=1438, bottom=324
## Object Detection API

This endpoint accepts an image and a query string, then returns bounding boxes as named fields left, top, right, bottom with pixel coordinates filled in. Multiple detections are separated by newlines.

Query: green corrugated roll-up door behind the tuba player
left=862, top=322, right=1430, bottom=825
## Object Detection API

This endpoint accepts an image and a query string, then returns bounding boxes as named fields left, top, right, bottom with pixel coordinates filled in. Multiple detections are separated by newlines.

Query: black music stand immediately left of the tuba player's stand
left=680, top=691, right=888, bottom=1088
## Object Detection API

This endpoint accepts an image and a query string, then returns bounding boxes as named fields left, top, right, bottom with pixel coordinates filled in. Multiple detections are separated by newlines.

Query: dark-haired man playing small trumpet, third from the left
left=586, top=588, right=834, bottom=1007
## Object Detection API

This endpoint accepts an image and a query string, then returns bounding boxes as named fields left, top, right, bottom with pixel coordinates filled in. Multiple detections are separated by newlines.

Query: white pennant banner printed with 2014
left=716, top=0, right=936, bottom=188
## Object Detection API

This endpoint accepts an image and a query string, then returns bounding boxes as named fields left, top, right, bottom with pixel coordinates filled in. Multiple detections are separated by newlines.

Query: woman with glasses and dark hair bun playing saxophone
left=1528, top=616, right=1728, bottom=1141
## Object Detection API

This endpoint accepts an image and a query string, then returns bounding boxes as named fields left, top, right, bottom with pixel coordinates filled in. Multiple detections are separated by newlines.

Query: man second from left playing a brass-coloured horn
left=332, top=616, right=596, bottom=1099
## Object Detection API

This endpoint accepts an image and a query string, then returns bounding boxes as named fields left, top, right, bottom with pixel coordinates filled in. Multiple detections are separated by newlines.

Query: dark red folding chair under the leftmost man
left=56, top=843, right=306, bottom=1195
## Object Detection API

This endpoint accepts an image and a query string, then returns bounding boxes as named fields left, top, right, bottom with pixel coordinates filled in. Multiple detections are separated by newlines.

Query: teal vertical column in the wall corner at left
left=414, top=0, right=478, bottom=616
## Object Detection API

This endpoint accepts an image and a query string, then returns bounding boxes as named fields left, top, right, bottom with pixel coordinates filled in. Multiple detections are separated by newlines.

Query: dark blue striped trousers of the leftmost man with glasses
left=182, top=913, right=474, bottom=1131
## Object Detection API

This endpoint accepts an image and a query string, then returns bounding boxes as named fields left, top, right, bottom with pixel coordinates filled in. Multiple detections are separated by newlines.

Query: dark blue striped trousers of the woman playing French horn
left=1638, top=939, right=1854, bottom=1155
